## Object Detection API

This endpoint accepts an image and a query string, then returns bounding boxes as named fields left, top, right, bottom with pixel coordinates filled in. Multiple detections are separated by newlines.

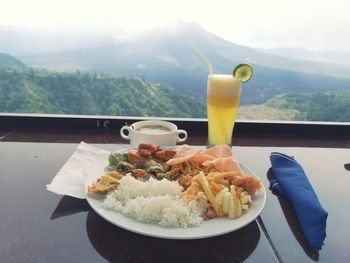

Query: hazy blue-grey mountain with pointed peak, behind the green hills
left=0, top=21, right=350, bottom=104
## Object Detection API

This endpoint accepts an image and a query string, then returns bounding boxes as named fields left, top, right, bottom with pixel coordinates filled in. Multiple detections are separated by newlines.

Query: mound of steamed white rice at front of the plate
left=103, top=175, right=207, bottom=227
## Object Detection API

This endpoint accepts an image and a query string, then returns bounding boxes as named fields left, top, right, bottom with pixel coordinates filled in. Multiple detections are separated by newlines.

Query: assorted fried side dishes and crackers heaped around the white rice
left=88, top=143, right=261, bottom=223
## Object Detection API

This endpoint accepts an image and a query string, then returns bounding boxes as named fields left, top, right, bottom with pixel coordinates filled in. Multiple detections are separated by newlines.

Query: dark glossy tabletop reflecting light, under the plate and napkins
left=0, top=139, right=350, bottom=262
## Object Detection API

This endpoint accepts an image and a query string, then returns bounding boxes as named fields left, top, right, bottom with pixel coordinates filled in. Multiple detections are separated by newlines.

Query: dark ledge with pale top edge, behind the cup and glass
left=0, top=113, right=350, bottom=138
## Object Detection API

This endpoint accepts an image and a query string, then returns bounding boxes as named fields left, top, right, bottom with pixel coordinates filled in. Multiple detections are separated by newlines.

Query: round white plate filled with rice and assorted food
left=85, top=144, right=266, bottom=239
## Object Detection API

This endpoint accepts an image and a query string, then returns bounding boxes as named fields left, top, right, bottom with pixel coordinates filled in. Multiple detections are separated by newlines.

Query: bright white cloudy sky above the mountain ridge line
left=0, top=0, right=350, bottom=50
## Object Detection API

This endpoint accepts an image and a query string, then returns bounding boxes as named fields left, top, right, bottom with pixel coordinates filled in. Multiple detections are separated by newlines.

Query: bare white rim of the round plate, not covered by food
left=85, top=159, right=266, bottom=239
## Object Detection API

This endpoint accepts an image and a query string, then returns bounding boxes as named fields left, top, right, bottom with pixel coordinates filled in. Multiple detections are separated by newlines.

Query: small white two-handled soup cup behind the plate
left=120, top=120, right=187, bottom=148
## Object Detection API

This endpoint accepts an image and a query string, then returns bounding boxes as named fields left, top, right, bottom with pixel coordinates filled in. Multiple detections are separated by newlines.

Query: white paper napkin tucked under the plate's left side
left=46, top=142, right=110, bottom=199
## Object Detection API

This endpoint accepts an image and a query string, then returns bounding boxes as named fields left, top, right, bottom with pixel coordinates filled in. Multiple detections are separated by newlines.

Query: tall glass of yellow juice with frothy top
left=207, top=74, right=241, bottom=147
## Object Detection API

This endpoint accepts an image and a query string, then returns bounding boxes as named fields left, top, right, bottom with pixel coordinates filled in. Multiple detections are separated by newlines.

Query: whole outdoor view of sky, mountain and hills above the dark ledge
left=0, top=0, right=350, bottom=122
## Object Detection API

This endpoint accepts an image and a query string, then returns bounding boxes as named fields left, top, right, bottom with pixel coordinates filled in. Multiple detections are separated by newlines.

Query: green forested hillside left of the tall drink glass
left=0, top=69, right=206, bottom=118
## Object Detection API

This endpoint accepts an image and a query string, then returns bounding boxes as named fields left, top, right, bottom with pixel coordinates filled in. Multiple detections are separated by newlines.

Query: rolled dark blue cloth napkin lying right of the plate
left=270, top=152, right=328, bottom=249
